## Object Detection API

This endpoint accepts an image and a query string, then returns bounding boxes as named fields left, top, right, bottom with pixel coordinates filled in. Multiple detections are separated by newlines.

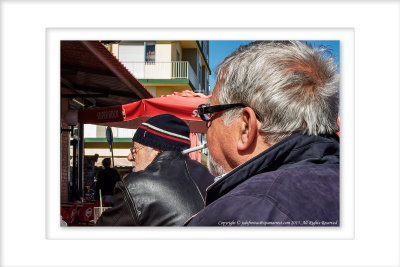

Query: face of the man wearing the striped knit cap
left=128, top=142, right=159, bottom=172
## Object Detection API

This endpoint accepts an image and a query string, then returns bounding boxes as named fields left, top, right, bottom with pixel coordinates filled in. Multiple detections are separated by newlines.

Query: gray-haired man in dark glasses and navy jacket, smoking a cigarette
left=187, top=41, right=340, bottom=226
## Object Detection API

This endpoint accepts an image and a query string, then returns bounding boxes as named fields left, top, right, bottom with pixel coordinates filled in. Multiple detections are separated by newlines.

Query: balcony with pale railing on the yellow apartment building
left=122, top=61, right=200, bottom=92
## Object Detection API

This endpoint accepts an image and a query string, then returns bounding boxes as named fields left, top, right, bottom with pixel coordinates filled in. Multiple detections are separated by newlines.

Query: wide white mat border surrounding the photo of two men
left=0, top=1, right=400, bottom=266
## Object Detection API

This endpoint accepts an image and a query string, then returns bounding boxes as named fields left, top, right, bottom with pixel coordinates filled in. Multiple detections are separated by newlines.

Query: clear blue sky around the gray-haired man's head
left=209, top=40, right=340, bottom=91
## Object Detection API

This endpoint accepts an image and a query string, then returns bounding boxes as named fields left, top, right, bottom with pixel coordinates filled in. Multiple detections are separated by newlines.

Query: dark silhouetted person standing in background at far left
left=95, top=158, right=121, bottom=204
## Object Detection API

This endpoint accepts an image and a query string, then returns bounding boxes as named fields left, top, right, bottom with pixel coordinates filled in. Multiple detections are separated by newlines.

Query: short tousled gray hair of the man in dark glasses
left=217, top=41, right=339, bottom=142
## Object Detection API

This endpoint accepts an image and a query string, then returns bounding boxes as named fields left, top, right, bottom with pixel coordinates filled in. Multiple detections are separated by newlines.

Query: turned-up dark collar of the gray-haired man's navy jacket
left=206, top=133, right=339, bottom=205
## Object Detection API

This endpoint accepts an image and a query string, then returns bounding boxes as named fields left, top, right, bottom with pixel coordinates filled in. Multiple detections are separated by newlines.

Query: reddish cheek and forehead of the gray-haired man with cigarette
left=207, top=81, right=236, bottom=176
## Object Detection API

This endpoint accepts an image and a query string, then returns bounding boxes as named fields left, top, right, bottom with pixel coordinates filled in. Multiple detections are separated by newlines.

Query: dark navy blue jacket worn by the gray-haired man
left=186, top=134, right=340, bottom=226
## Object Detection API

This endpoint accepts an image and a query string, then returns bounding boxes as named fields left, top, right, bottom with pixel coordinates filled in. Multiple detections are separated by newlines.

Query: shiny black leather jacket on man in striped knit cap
left=96, top=151, right=213, bottom=226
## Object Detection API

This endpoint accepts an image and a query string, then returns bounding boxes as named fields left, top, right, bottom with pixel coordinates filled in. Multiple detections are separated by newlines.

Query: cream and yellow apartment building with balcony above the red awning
left=104, top=41, right=211, bottom=97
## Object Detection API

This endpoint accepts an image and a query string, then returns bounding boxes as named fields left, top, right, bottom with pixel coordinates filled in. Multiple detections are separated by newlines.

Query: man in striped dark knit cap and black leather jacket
left=96, top=114, right=213, bottom=226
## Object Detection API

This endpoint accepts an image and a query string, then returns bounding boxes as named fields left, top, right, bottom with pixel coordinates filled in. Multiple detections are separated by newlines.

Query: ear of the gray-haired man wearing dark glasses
left=237, top=107, right=258, bottom=152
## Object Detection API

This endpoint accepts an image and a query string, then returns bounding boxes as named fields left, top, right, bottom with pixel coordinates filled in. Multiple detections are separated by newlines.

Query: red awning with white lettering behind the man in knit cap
left=78, top=91, right=210, bottom=133
